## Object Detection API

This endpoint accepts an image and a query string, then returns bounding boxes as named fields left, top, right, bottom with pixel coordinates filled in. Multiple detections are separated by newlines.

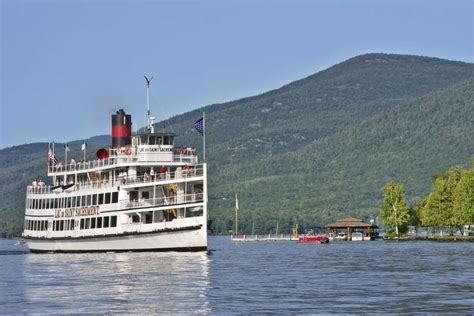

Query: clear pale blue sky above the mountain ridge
left=0, top=0, right=474, bottom=148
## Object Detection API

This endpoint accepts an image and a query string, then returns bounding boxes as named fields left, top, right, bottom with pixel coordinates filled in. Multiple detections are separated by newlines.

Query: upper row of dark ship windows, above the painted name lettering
left=26, top=192, right=118, bottom=210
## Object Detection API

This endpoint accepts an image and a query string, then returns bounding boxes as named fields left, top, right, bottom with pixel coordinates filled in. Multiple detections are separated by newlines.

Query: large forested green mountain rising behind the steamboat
left=0, top=54, right=474, bottom=237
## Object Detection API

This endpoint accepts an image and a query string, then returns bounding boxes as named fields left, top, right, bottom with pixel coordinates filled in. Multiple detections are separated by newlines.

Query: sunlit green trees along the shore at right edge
left=380, top=157, right=474, bottom=241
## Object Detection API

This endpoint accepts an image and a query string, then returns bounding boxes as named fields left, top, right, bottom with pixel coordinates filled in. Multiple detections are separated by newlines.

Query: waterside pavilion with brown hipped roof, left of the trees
left=324, top=217, right=378, bottom=240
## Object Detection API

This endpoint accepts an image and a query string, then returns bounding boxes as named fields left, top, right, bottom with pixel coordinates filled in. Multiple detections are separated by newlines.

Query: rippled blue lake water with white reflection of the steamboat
left=0, top=237, right=474, bottom=315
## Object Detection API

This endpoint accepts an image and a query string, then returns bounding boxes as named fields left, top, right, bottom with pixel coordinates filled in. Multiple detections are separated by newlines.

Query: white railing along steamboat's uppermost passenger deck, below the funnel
left=48, top=154, right=197, bottom=173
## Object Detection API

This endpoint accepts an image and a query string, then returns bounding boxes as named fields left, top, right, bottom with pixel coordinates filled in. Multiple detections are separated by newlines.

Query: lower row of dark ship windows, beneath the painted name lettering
left=25, top=215, right=117, bottom=231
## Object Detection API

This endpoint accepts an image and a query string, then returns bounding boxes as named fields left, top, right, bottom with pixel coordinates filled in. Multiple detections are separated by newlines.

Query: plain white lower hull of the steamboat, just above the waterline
left=25, top=226, right=207, bottom=252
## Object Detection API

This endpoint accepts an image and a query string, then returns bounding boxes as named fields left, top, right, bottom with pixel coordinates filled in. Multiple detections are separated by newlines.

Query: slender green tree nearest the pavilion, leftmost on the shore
left=380, top=181, right=410, bottom=237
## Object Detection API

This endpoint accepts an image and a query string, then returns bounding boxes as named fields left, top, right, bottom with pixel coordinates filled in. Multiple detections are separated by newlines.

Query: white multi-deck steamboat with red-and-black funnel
left=23, top=80, right=207, bottom=252
